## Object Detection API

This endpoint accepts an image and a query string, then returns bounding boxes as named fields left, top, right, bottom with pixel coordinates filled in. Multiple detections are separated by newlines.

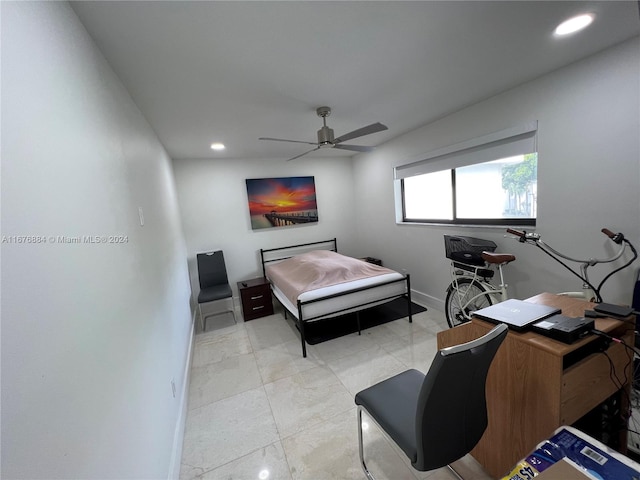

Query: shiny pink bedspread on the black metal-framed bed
left=266, top=250, right=394, bottom=305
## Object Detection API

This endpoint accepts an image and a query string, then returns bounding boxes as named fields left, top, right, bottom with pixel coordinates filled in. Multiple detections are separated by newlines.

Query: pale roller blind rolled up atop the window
left=394, top=121, right=538, bottom=180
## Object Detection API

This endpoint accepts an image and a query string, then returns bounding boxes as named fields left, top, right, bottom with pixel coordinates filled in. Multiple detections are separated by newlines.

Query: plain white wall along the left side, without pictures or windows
left=0, top=2, right=192, bottom=479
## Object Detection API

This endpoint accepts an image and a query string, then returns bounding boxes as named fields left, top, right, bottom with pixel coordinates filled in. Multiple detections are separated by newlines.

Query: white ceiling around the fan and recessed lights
left=72, top=1, right=640, bottom=159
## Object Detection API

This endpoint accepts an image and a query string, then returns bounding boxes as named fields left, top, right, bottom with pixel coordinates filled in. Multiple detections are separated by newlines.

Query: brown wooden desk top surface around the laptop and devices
left=472, top=293, right=635, bottom=356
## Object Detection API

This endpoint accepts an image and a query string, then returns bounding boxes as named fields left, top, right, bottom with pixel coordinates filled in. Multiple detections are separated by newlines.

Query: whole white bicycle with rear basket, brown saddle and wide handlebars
left=445, top=228, right=638, bottom=327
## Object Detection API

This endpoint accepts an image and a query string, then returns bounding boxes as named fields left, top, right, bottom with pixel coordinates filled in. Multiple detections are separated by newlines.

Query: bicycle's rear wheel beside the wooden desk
left=444, top=278, right=497, bottom=328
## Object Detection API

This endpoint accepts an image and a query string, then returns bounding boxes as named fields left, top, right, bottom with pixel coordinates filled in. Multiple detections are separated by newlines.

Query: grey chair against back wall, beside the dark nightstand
left=196, top=250, right=236, bottom=332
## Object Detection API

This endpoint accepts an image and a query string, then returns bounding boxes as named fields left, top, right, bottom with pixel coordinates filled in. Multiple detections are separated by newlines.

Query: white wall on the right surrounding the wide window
left=354, top=37, right=640, bottom=308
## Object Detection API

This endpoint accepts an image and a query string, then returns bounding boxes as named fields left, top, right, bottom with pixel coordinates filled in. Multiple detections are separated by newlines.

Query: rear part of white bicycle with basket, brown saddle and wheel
left=444, top=235, right=516, bottom=328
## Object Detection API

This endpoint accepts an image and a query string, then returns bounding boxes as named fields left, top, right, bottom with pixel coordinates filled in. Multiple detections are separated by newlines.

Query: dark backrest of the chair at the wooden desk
left=413, top=324, right=508, bottom=471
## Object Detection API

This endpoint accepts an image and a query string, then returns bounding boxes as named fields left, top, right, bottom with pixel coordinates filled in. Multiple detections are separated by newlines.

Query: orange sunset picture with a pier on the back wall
left=247, top=177, right=318, bottom=230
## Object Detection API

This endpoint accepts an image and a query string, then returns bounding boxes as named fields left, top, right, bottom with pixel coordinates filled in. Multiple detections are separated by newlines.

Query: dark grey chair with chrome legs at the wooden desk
left=355, top=324, right=507, bottom=480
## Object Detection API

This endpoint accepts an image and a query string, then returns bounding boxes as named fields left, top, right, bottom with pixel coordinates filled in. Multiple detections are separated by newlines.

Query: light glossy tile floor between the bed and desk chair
left=180, top=309, right=490, bottom=480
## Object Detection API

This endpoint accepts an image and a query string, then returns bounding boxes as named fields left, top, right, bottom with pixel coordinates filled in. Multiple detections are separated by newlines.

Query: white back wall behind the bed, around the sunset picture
left=173, top=156, right=360, bottom=305
